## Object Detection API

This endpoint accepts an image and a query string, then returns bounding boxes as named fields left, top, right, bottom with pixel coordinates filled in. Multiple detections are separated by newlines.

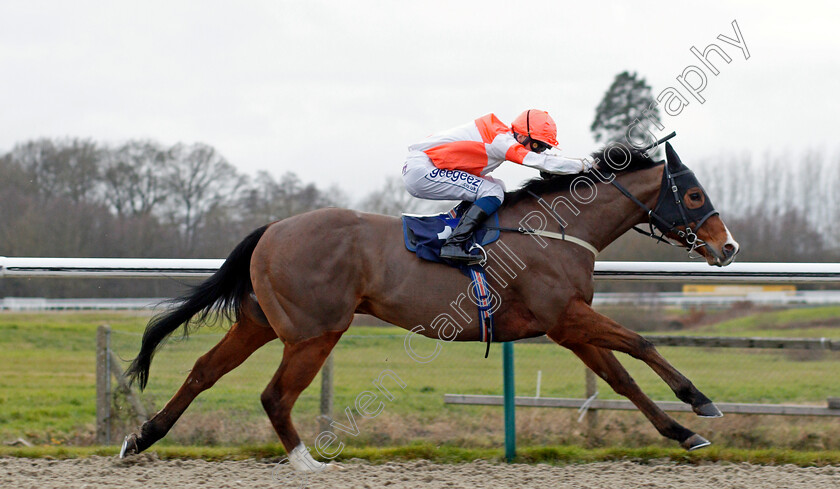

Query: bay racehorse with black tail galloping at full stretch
left=120, top=143, right=738, bottom=471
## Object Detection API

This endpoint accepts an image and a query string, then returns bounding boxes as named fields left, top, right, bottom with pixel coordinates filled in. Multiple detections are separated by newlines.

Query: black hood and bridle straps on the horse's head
left=610, top=132, right=718, bottom=255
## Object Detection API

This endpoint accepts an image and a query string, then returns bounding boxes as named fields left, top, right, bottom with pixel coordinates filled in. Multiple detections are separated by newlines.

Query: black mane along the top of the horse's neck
left=503, top=146, right=662, bottom=206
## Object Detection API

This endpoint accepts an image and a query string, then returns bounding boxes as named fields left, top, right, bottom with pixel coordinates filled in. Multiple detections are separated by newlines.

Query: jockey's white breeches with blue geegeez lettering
left=403, top=151, right=505, bottom=202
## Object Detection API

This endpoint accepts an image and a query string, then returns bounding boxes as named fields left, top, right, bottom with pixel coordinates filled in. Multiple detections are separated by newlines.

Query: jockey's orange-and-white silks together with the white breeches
left=403, top=114, right=590, bottom=202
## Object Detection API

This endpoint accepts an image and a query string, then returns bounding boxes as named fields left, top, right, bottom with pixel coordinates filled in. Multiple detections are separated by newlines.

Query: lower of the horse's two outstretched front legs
left=564, top=344, right=710, bottom=450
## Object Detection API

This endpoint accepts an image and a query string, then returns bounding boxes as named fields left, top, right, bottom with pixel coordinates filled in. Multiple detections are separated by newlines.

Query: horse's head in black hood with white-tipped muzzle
left=651, top=143, right=739, bottom=267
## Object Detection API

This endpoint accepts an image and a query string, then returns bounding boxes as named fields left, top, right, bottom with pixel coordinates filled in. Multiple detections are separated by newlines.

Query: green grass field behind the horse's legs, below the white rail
left=0, top=307, right=840, bottom=449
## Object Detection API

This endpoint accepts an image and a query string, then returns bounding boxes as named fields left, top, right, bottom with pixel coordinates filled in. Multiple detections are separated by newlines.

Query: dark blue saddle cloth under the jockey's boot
left=402, top=203, right=501, bottom=268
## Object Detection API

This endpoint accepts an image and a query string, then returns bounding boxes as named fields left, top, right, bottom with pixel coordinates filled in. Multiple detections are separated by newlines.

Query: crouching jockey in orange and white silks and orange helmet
left=402, top=109, right=592, bottom=264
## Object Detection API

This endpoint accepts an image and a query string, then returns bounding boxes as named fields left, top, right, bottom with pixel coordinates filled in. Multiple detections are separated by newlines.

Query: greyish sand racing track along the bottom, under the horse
left=0, top=454, right=840, bottom=489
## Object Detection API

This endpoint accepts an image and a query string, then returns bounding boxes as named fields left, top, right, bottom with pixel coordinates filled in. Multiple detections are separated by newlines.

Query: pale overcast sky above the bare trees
left=0, top=0, right=840, bottom=197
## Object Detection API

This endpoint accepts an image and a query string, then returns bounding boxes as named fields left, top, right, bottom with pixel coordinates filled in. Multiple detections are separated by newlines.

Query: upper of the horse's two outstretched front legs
left=549, top=301, right=723, bottom=418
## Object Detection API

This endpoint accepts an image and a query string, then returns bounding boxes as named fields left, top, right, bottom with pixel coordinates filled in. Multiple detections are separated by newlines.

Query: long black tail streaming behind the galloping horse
left=125, top=225, right=268, bottom=390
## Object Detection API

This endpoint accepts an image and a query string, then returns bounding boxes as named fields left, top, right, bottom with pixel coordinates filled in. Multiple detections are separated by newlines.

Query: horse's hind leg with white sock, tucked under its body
left=261, top=332, right=342, bottom=472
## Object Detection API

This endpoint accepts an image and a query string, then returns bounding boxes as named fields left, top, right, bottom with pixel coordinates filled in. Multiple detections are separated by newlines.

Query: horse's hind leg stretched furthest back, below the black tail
left=120, top=315, right=277, bottom=457
